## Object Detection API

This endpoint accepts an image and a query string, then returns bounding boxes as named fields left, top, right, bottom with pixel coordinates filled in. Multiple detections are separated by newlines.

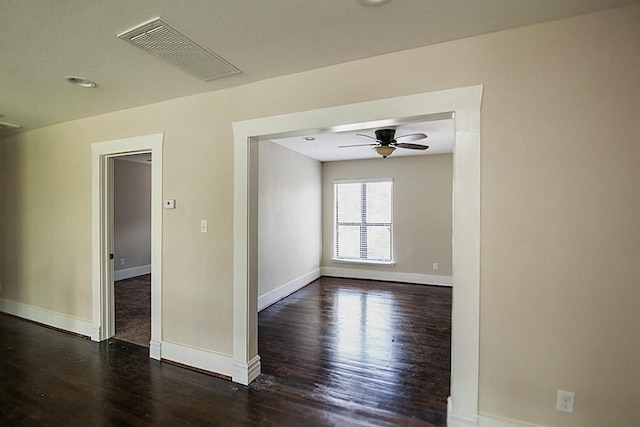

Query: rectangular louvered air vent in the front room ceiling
left=118, top=18, right=240, bottom=80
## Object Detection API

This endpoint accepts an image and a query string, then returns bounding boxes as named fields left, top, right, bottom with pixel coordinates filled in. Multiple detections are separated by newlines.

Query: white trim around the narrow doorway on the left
left=91, top=133, right=164, bottom=360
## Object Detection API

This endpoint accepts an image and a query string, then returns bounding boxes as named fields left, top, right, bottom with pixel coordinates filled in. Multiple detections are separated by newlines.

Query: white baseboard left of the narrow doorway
left=0, top=299, right=93, bottom=337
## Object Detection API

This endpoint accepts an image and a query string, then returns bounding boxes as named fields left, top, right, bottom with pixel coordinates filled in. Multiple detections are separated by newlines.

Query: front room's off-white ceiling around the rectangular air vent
left=0, top=0, right=635, bottom=129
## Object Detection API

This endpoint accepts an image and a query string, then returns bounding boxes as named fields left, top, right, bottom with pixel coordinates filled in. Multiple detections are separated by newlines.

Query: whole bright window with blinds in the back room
left=334, top=179, right=393, bottom=264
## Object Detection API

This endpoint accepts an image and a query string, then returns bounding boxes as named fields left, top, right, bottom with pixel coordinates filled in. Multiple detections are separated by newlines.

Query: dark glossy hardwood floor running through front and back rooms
left=0, top=278, right=451, bottom=426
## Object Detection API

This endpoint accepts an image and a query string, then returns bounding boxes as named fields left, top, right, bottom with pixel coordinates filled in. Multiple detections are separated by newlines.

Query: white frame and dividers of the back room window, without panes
left=331, top=178, right=395, bottom=266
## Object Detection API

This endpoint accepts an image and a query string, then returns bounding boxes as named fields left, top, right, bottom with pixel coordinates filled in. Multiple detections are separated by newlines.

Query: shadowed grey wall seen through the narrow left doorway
left=113, top=159, right=151, bottom=271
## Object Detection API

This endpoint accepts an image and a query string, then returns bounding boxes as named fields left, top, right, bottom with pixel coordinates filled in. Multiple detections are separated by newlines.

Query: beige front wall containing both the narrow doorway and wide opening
left=0, top=5, right=640, bottom=426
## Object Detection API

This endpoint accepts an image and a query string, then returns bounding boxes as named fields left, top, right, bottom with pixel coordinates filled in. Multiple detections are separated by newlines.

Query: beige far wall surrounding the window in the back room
left=322, top=154, right=453, bottom=276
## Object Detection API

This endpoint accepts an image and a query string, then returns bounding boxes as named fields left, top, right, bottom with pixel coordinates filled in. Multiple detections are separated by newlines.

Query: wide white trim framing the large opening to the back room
left=232, top=85, right=483, bottom=423
